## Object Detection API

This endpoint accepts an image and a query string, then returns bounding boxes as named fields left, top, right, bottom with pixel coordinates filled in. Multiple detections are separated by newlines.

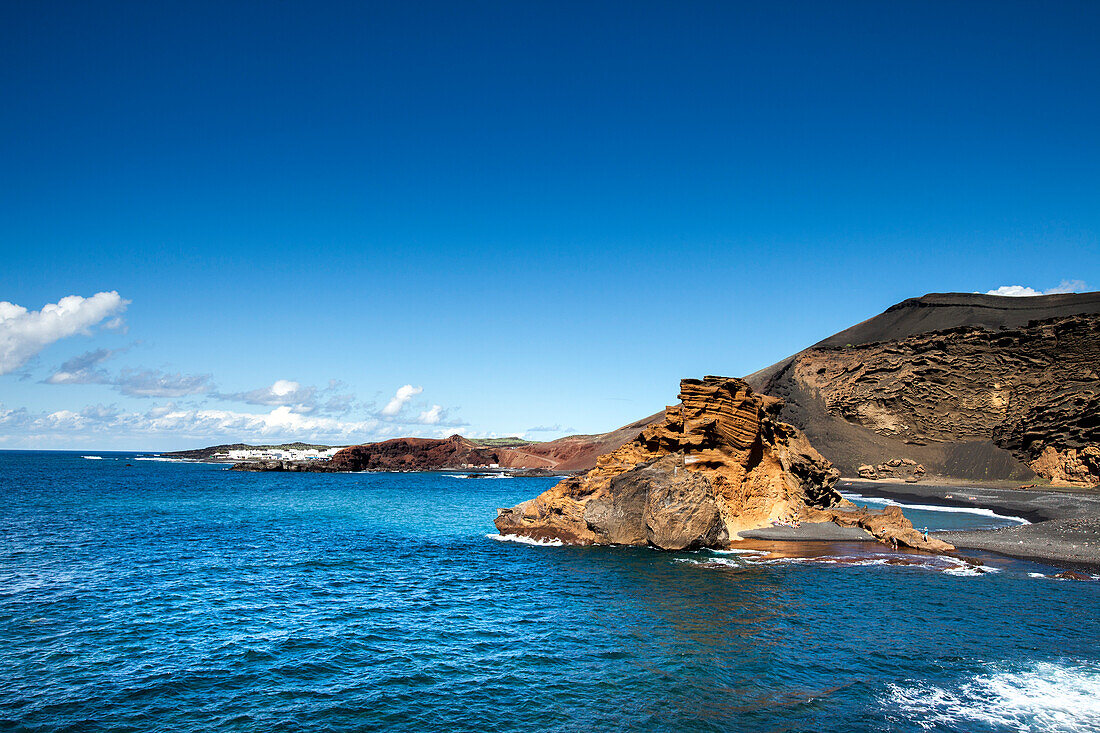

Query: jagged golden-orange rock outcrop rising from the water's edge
left=496, top=376, right=840, bottom=549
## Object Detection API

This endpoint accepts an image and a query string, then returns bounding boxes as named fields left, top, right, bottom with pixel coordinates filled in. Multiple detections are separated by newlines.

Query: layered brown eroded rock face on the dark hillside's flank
left=765, top=314, right=1100, bottom=486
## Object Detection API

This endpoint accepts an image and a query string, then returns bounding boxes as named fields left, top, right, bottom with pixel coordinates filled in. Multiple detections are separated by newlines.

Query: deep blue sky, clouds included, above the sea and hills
left=0, top=2, right=1100, bottom=449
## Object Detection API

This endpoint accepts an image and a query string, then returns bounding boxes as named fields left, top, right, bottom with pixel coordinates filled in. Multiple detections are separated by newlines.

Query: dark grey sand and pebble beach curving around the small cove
left=837, top=479, right=1100, bottom=570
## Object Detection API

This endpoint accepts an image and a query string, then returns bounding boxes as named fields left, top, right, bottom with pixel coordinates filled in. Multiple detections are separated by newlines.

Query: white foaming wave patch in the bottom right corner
left=883, top=663, right=1100, bottom=733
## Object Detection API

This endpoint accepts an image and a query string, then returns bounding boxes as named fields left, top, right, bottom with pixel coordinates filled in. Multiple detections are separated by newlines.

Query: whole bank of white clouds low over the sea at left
left=0, top=291, right=466, bottom=447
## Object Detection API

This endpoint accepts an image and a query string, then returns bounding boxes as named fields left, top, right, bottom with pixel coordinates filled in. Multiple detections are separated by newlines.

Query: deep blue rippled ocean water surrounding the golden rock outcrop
left=0, top=452, right=1100, bottom=732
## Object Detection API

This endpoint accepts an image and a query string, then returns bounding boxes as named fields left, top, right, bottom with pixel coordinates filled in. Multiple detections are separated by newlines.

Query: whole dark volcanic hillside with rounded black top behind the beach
left=746, top=293, right=1100, bottom=485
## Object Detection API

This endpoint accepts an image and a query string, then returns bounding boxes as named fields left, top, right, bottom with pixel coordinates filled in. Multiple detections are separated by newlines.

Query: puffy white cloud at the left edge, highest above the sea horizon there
left=0, top=291, right=130, bottom=374
